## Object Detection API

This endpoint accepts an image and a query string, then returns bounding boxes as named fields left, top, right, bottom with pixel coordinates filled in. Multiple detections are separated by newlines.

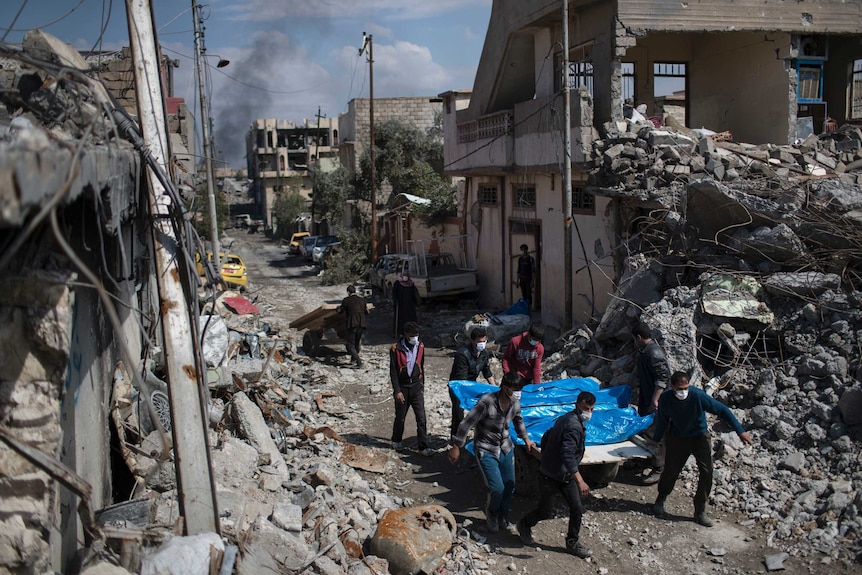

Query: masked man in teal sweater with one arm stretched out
left=653, top=371, right=751, bottom=527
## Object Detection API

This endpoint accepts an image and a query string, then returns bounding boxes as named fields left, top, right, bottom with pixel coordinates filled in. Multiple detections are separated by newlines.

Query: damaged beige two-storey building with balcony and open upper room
left=442, top=0, right=862, bottom=330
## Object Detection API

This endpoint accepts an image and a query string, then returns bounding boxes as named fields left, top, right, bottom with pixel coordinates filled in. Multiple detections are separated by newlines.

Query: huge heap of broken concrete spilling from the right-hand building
left=545, top=119, right=862, bottom=563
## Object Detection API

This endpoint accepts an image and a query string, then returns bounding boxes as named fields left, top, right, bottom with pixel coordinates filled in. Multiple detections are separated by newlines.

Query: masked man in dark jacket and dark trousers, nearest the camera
left=518, top=391, right=596, bottom=559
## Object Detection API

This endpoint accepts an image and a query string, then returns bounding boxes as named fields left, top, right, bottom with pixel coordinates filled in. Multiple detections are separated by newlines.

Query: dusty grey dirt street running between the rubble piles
left=226, top=230, right=862, bottom=575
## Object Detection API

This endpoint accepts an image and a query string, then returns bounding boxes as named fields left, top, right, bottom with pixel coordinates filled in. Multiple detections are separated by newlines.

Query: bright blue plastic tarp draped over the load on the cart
left=449, top=377, right=654, bottom=451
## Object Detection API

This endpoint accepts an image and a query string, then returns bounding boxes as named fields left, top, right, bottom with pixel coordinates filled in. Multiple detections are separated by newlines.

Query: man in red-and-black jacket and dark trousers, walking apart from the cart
left=389, top=321, right=432, bottom=456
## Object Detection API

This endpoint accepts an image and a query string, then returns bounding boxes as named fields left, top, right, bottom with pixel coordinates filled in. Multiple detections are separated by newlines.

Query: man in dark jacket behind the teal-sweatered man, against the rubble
left=632, top=322, right=670, bottom=485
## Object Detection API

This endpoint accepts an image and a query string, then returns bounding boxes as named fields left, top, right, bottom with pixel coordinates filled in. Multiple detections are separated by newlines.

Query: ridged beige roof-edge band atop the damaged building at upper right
left=618, top=0, right=862, bottom=34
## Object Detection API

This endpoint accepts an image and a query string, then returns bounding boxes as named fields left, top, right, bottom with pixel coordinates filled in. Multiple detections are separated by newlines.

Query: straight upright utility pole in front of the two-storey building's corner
left=563, top=0, right=573, bottom=331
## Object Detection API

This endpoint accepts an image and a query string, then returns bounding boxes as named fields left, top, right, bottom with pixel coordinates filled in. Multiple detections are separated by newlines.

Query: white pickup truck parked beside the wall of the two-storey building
left=383, top=253, right=479, bottom=299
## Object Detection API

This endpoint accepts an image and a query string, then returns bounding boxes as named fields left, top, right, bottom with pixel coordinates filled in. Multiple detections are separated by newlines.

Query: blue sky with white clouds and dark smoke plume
left=0, top=0, right=492, bottom=168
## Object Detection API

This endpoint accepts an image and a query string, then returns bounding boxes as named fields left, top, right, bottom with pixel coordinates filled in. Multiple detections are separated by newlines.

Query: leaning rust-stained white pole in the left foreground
left=126, top=0, right=219, bottom=535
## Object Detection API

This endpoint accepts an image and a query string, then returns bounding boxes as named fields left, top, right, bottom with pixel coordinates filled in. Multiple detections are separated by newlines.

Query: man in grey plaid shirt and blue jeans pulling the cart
left=449, top=371, right=536, bottom=533
